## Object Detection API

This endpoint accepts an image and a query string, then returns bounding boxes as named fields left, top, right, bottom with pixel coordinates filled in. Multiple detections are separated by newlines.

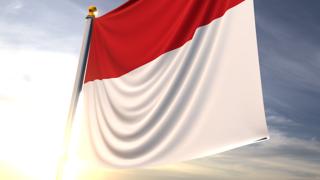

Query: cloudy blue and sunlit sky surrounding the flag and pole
left=0, top=0, right=320, bottom=180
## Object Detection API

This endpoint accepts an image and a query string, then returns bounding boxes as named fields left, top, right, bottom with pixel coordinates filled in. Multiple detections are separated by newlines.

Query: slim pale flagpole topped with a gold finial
left=56, top=6, right=97, bottom=180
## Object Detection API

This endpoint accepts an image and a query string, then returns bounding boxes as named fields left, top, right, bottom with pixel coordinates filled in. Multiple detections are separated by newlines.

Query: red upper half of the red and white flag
left=85, top=0, right=244, bottom=82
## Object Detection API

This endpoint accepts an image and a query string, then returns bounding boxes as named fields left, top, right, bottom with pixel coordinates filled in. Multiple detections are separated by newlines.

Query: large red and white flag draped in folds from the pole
left=79, top=0, right=268, bottom=168
